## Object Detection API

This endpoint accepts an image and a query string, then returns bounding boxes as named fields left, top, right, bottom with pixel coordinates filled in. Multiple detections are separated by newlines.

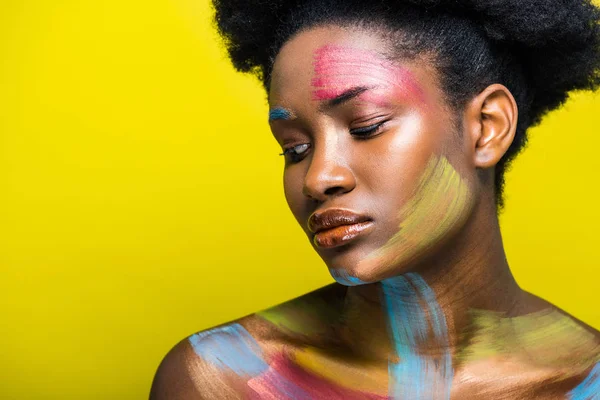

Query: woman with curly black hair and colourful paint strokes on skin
left=151, top=0, right=600, bottom=400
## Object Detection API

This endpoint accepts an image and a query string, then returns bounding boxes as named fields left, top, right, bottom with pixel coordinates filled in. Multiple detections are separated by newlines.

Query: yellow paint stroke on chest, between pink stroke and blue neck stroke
left=291, top=347, right=388, bottom=395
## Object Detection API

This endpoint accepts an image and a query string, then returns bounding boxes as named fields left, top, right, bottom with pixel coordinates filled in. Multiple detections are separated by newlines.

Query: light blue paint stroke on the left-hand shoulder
left=188, top=323, right=269, bottom=377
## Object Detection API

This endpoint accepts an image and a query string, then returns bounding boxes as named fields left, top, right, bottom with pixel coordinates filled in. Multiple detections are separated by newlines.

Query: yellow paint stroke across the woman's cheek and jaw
left=356, top=156, right=472, bottom=280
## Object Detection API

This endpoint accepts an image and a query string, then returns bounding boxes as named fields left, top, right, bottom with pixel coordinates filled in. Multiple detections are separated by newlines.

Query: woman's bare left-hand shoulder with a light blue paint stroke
left=150, top=285, right=343, bottom=400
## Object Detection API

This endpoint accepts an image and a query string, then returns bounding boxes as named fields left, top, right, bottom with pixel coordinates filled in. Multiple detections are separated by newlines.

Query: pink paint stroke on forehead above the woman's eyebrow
left=311, top=45, right=425, bottom=105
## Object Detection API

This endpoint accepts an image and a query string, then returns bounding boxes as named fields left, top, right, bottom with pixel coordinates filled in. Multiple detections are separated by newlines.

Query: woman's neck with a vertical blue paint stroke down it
left=343, top=198, right=533, bottom=365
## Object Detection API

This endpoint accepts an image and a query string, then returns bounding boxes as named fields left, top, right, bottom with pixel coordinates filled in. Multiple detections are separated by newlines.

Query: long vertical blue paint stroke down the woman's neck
left=382, top=273, right=454, bottom=399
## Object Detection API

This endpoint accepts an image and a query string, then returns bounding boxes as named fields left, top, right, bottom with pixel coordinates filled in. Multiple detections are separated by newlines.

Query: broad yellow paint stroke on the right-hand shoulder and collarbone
left=457, top=309, right=600, bottom=375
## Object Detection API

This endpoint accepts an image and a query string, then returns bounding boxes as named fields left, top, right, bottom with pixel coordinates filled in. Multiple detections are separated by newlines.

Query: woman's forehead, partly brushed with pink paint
left=269, top=25, right=436, bottom=106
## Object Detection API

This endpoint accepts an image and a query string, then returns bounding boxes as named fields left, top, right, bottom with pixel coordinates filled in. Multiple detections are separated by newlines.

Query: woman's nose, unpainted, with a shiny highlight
left=302, top=143, right=356, bottom=202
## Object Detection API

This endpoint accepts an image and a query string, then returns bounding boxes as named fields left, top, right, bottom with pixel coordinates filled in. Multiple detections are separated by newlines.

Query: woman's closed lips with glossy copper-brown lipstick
left=308, top=208, right=373, bottom=248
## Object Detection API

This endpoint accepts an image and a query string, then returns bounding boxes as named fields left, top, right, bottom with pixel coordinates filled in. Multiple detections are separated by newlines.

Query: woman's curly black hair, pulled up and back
left=213, top=0, right=600, bottom=210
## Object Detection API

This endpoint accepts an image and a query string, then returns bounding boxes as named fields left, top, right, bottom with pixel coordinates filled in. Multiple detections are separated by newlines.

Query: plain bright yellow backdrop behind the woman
left=0, top=0, right=600, bottom=400
